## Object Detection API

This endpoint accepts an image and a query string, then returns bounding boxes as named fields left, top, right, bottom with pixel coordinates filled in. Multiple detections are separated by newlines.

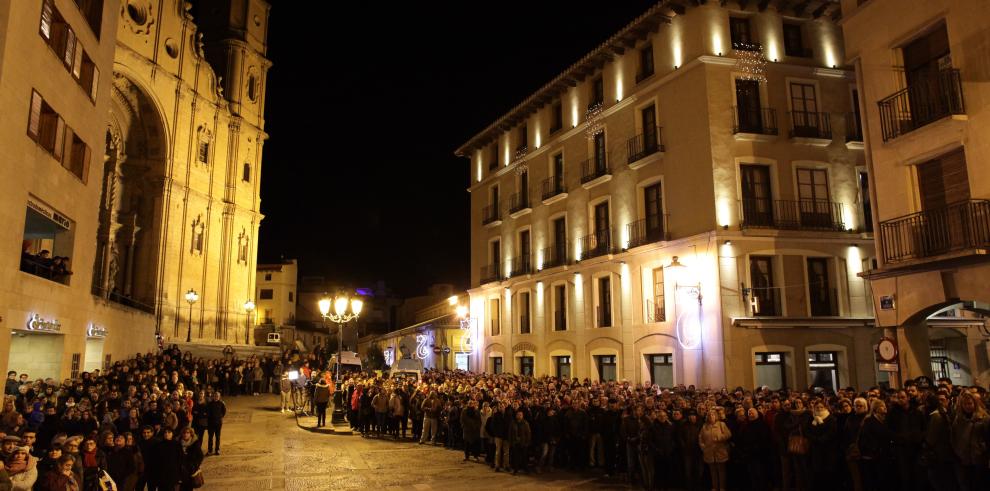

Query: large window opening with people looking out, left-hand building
left=20, top=198, right=74, bottom=285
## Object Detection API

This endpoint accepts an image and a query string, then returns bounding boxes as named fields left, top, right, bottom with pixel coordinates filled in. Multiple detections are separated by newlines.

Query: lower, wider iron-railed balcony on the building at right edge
left=880, top=200, right=990, bottom=263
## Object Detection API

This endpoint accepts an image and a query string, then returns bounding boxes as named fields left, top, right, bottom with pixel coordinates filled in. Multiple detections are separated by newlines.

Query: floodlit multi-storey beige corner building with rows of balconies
left=457, top=1, right=884, bottom=388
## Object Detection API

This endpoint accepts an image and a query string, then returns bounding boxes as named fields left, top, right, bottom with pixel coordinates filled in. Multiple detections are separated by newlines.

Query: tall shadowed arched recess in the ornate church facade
left=93, top=72, right=167, bottom=313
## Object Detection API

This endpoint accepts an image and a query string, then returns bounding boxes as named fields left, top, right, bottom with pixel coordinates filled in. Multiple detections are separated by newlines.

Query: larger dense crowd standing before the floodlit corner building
left=324, top=367, right=990, bottom=491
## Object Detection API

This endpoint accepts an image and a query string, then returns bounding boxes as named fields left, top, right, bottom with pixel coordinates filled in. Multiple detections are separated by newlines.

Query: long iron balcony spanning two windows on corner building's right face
left=739, top=199, right=846, bottom=232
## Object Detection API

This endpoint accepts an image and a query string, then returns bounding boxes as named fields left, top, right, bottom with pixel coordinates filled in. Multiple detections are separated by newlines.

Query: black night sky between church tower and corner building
left=259, top=0, right=655, bottom=295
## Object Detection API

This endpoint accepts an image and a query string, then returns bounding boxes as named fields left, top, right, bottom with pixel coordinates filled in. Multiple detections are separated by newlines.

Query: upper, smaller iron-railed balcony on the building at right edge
left=877, top=68, right=966, bottom=142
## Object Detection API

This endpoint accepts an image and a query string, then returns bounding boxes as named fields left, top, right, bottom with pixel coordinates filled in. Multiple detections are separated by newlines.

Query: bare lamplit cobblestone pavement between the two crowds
left=202, top=395, right=628, bottom=491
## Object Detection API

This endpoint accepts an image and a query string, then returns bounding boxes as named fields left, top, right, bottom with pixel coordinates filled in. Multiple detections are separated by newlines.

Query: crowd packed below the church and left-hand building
left=0, top=346, right=298, bottom=491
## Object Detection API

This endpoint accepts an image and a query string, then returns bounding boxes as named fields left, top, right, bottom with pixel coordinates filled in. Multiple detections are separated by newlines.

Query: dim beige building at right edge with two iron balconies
left=842, top=0, right=990, bottom=386
